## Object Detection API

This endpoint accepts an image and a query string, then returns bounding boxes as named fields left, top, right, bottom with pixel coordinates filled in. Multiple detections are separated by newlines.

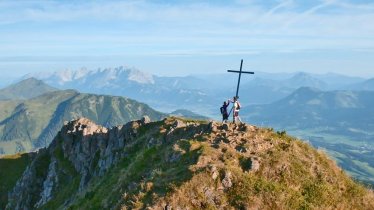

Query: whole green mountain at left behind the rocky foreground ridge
left=0, top=81, right=165, bottom=154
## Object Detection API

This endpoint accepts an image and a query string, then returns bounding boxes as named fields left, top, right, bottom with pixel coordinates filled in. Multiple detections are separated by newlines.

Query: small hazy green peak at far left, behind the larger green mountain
left=0, top=77, right=57, bottom=100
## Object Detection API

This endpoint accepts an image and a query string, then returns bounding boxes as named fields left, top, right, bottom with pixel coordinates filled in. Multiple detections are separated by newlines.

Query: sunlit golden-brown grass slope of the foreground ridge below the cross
left=155, top=129, right=374, bottom=209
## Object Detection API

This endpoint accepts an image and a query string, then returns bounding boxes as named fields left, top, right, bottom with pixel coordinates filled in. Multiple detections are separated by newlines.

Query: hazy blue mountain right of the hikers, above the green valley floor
left=243, top=87, right=374, bottom=132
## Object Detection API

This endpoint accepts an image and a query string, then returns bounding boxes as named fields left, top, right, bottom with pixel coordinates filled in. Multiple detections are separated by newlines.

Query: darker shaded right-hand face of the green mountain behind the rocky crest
left=34, top=93, right=166, bottom=147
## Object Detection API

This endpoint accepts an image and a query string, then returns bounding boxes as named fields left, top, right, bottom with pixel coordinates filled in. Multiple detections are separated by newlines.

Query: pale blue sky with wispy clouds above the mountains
left=0, top=0, right=374, bottom=78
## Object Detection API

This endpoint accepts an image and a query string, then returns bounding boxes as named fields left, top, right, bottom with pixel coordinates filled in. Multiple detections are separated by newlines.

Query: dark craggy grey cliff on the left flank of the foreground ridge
left=7, top=116, right=151, bottom=209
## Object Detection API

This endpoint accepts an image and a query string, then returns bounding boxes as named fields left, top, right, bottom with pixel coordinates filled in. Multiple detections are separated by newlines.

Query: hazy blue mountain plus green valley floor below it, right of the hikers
left=240, top=87, right=374, bottom=183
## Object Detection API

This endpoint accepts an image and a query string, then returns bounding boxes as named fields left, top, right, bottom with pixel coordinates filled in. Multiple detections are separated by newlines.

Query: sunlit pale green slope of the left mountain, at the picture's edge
left=0, top=90, right=78, bottom=154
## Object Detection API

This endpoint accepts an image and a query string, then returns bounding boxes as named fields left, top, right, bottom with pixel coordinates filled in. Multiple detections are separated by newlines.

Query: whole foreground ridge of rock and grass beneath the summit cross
left=0, top=117, right=374, bottom=209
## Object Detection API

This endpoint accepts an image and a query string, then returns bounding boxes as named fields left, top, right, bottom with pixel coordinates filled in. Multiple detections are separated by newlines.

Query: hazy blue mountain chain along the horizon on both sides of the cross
left=23, top=66, right=372, bottom=117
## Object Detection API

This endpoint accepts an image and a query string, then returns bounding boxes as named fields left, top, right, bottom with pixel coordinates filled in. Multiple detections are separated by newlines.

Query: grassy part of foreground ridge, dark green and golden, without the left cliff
left=41, top=118, right=374, bottom=209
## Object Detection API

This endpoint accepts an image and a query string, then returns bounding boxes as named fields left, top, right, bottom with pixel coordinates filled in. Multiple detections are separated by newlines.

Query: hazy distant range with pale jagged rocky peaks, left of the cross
left=23, top=67, right=209, bottom=112
